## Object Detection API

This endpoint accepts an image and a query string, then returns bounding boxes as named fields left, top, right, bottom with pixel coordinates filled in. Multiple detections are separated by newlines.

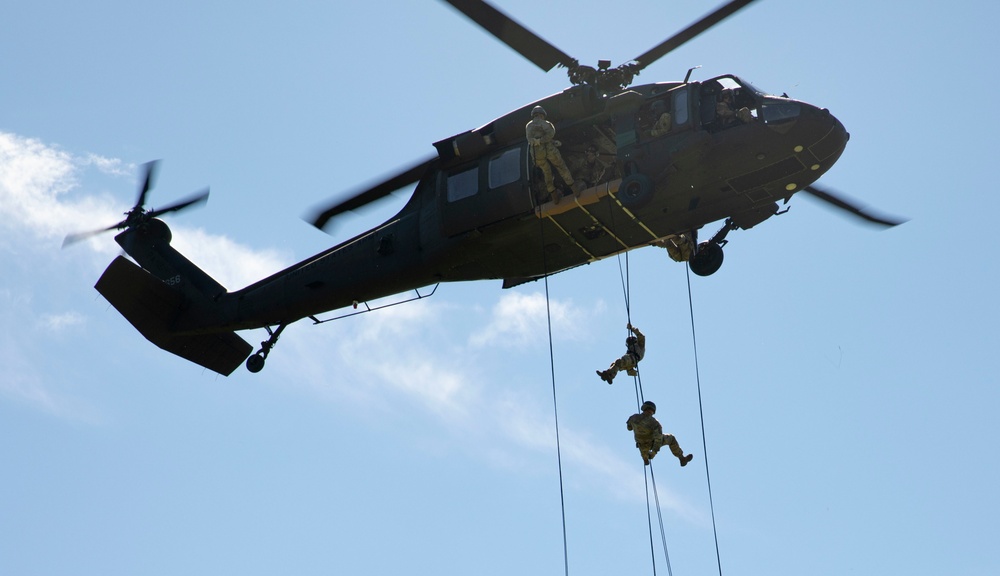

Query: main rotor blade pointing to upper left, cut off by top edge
left=445, top=0, right=577, bottom=72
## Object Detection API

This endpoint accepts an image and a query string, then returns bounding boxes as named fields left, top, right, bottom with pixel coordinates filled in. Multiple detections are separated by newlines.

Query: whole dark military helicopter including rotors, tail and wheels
left=67, top=0, right=897, bottom=375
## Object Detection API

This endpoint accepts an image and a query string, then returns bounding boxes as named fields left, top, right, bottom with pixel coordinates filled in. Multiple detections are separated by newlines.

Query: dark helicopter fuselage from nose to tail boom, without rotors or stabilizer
left=150, top=76, right=848, bottom=332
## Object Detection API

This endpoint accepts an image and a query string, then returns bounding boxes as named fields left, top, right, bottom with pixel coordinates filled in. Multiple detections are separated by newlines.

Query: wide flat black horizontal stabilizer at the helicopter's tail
left=95, top=256, right=253, bottom=376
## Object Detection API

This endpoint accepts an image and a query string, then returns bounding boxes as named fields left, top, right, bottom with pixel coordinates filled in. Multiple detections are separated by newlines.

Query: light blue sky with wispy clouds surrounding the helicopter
left=0, top=0, right=1000, bottom=575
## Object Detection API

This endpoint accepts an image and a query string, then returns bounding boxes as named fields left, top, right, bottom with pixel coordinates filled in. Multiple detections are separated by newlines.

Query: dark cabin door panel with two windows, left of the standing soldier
left=438, top=145, right=534, bottom=236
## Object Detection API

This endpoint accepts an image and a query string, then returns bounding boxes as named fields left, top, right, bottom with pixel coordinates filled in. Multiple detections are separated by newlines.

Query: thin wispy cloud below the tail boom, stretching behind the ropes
left=279, top=292, right=698, bottom=521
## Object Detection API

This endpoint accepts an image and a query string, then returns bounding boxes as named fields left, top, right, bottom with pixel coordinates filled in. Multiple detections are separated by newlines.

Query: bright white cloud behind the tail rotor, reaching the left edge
left=0, top=132, right=290, bottom=418
